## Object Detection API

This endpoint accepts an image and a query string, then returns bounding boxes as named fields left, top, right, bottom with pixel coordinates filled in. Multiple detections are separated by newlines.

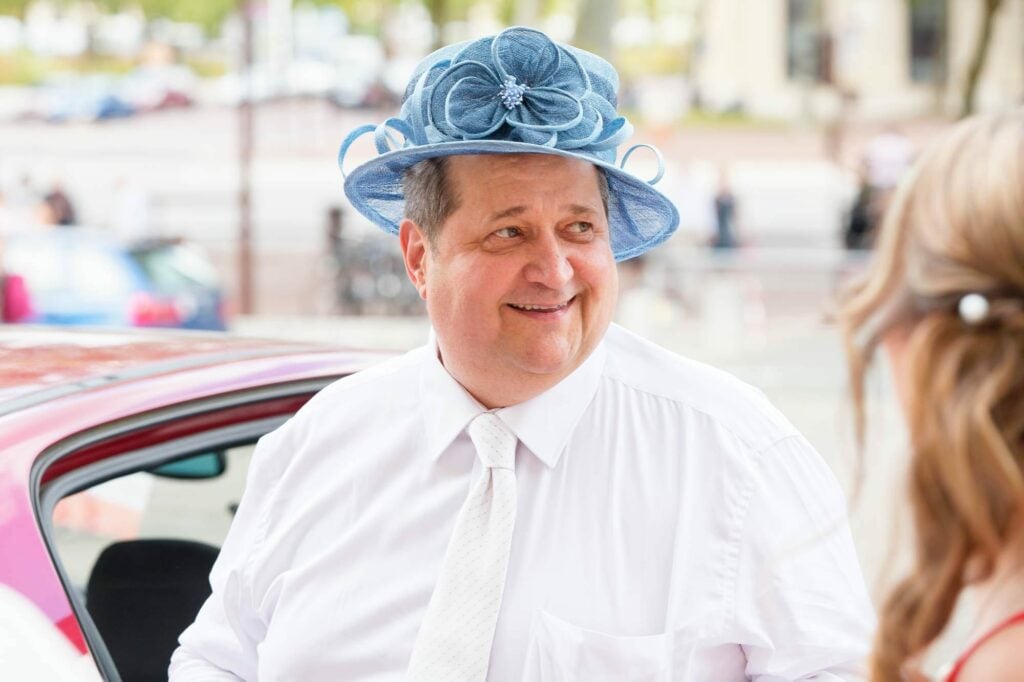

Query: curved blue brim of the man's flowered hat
left=339, top=140, right=679, bottom=261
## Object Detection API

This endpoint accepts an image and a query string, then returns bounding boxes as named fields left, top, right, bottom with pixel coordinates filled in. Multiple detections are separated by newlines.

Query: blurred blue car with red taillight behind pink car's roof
left=2, top=227, right=227, bottom=330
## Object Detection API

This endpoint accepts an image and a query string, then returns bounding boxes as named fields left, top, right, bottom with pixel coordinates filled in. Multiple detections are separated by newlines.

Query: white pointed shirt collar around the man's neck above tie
left=420, top=338, right=606, bottom=467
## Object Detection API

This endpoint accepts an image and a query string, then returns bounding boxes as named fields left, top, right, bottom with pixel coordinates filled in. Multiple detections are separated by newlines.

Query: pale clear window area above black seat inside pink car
left=53, top=445, right=252, bottom=595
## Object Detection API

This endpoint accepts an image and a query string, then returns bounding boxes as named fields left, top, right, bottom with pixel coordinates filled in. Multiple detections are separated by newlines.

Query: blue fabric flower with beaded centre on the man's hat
left=425, top=28, right=629, bottom=153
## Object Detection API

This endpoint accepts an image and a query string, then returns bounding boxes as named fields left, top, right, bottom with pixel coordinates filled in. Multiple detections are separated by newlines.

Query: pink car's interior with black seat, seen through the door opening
left=45, top=443, right=253, bottom=682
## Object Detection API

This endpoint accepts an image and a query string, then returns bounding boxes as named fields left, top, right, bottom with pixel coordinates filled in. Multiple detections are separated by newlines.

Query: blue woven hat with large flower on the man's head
left=338, top=27, right=679, bottom=260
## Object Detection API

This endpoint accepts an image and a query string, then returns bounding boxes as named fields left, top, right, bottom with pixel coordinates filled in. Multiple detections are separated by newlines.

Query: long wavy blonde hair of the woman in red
left=841, top=110, right=1024, bottom=682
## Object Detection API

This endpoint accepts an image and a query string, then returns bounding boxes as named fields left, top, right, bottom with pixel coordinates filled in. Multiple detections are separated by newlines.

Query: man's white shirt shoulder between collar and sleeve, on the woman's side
left=605, top=326, right=798, bottom=451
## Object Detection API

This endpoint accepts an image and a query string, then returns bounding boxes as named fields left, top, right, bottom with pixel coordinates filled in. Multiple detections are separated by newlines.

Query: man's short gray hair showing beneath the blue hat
left=401, top=157, right=608, bottom=247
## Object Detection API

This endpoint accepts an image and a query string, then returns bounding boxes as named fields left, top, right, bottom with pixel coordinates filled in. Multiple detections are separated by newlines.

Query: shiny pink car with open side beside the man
left=0, top=327, right=385, bottom=681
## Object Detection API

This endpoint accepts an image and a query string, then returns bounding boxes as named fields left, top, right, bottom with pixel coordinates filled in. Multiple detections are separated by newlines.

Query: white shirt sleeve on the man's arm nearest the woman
left=733, top=435, right=874, bottom=682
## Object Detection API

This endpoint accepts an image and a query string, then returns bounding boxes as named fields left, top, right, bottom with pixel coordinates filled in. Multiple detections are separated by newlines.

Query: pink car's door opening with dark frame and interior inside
left=33, top=377, right=333, bottom=681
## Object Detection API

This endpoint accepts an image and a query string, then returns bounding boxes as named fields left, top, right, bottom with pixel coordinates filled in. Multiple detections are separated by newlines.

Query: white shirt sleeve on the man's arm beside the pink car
left=168, top=426, right=288, bottom=682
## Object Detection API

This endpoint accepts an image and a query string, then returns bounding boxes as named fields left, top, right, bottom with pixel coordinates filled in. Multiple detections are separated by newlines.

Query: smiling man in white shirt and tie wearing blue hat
left=171, top=29, right=872, bottom=682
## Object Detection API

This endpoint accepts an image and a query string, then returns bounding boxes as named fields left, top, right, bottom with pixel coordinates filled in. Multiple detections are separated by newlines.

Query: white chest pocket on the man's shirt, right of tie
left=522, top=610, right=685, bottom=682
